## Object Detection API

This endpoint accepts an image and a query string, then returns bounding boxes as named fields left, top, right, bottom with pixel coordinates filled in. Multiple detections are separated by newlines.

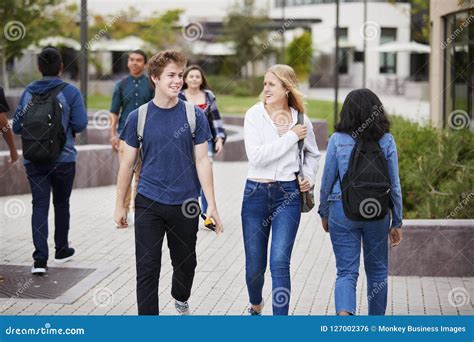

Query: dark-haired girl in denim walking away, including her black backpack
left=319, top=89, right=402, bottom=315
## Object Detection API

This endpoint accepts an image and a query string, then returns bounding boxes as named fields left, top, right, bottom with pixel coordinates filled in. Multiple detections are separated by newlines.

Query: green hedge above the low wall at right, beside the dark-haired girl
left=391, top=117, right=474, bottom=219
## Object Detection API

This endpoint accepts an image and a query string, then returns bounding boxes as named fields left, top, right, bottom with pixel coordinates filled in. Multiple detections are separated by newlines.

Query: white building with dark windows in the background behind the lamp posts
left=270, top=0, right=411, bottom=90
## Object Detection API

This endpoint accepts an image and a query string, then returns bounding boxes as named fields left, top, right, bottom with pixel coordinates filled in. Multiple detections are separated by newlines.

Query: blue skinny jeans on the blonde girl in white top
left=241, top=180, right=301, bottom=315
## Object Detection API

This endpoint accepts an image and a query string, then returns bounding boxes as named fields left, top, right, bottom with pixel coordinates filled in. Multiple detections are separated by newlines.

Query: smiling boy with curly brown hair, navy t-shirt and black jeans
left=115, top=50, right=223, bottom=315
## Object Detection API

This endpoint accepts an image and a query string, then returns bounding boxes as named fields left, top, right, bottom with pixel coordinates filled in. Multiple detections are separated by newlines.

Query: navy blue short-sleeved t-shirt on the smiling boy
left=120, top=100, right=211, bottom=205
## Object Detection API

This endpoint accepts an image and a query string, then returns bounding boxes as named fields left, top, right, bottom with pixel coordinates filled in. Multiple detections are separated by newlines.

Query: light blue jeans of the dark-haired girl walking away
left=329, top=201, right=390, bottom=315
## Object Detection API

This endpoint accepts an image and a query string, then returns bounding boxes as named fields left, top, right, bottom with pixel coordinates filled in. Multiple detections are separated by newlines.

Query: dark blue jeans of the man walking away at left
left=25, top=163, right=76, bottom=261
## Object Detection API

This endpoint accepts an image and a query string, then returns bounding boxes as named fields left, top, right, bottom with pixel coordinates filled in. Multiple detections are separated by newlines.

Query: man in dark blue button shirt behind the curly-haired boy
left=110, top=50, right=154, bottom=223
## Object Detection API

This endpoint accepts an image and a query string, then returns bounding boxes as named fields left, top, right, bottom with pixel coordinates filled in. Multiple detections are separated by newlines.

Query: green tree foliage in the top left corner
left=0, top=0, right=59, bottom=89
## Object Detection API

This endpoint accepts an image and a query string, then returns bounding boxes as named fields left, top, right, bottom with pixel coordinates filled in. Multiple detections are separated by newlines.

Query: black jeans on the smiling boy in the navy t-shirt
left=135, top=194, right=199, bottom=315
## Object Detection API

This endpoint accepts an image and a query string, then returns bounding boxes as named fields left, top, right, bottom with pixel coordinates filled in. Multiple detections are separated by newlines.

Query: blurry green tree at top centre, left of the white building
left=224, top=0, right=271, bottom=78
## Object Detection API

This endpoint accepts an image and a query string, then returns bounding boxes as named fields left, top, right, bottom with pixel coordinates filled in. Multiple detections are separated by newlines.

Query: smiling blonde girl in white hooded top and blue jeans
left=241, top=64, right=320, bottom=315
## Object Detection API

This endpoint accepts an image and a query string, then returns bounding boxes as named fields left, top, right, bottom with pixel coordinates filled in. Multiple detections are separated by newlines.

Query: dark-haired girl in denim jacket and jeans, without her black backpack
left=319, top=89, right=402, bottom=315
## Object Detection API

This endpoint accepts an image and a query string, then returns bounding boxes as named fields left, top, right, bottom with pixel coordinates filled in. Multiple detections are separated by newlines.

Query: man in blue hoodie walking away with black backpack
left=13, top=47, right=87, bottom=275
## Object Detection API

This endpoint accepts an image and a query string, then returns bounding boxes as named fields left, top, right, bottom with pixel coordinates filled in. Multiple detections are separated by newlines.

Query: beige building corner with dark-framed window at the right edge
left=430, top=0, right=474, bottom=130
